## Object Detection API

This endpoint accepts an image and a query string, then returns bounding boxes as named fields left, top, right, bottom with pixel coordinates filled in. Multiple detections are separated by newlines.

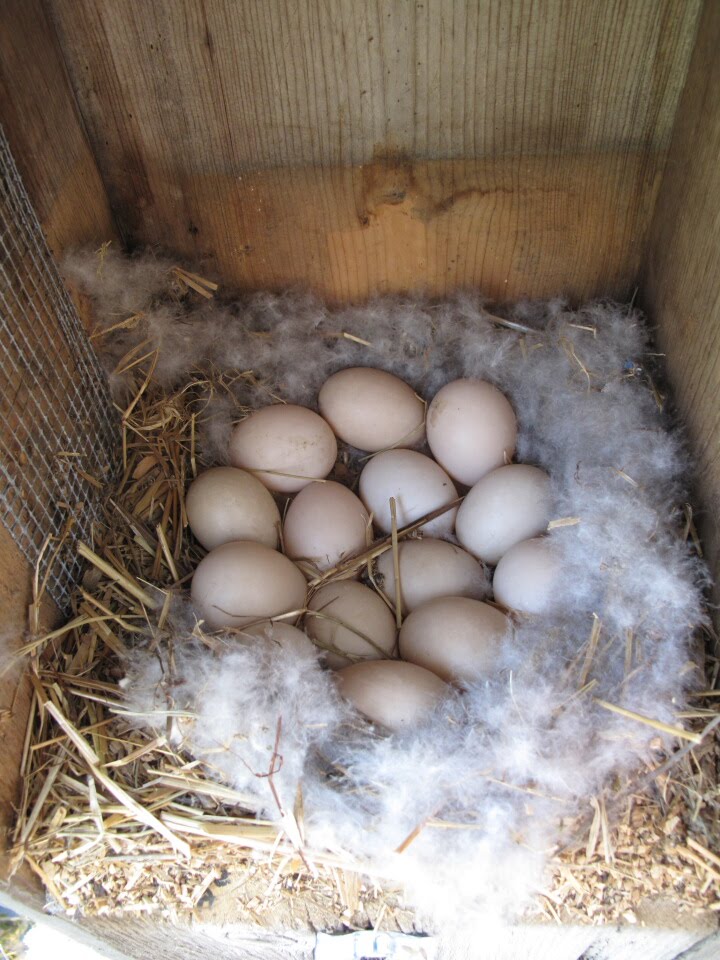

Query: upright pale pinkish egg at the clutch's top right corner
left=427, top=380, right=517, bottom=487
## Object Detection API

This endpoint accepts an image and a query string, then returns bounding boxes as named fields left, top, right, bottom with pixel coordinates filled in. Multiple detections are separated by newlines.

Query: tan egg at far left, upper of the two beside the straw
left=185, top=467, right=280, bottom=550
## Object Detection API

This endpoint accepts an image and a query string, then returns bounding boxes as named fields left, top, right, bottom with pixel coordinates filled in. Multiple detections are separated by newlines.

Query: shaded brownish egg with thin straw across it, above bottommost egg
left=305, top=580, right=396, bottom=669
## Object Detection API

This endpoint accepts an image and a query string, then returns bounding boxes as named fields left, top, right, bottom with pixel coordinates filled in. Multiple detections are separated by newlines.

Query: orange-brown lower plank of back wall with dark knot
left=5, top=154, right=658, bottom=301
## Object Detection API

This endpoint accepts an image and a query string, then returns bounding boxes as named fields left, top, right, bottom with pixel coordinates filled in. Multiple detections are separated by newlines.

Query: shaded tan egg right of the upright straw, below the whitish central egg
left=377, top=537, right=489, bottom=615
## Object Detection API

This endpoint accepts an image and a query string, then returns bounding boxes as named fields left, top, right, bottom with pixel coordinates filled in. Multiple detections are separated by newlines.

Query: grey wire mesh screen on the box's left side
left=0, top=127, right=114, bottom=609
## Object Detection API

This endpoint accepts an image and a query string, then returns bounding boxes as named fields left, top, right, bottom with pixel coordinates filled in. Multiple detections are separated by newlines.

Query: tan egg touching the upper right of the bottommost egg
left=400, top=597, right=511, bottom=682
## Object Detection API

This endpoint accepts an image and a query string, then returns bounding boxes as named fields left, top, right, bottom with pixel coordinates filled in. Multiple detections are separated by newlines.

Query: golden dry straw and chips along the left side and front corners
left=2, top=275, right=720, bottom=930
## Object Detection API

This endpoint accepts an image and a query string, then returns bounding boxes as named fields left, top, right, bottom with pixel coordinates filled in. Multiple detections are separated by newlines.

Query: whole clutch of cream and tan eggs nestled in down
left=186, top=367, right=560, bottom=731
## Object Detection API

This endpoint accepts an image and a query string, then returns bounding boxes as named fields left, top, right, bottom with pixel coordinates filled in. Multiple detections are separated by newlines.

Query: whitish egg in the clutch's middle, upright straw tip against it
left=360, top=450, right=458, bottom=537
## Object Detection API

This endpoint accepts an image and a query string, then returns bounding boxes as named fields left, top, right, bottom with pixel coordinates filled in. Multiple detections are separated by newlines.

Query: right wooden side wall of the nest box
left=643, top=0, right=720, bottom=602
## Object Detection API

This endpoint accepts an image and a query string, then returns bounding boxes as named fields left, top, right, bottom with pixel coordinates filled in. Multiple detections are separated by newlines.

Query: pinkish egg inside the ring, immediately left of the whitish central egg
left=283, top=480, right=370, bottom=571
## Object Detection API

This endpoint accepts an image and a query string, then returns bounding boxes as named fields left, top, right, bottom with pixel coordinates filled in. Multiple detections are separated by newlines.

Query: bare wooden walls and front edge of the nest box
left=0, top=0, right=720, bottom=960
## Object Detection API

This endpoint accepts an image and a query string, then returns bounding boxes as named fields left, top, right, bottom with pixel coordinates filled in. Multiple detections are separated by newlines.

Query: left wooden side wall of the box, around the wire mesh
left=0, top=0, right=115, bottom=877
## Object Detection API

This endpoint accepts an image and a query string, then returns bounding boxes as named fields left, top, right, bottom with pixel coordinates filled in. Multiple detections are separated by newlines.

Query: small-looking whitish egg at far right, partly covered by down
left=493, top=539, right=560, bottom=613
